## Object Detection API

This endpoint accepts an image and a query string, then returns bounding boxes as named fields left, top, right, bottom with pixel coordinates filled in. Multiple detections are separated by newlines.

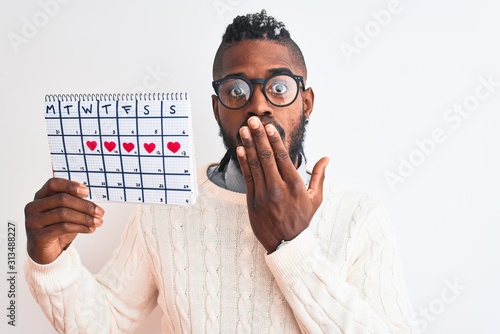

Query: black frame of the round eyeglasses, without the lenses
left=212, top=72, right=305, bottom=110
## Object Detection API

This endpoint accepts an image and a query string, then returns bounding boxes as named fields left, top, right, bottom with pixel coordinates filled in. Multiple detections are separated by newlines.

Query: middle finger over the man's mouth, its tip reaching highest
left=248, top=116, right=281, bottom=185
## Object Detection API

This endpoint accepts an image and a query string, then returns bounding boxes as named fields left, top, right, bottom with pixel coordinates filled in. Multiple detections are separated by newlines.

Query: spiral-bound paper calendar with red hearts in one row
left=44, top=93, right=197, bottom=205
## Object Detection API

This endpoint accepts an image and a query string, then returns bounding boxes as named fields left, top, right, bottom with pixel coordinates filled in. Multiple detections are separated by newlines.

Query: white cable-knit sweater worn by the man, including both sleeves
left=25, top=166, right=411, bottom=334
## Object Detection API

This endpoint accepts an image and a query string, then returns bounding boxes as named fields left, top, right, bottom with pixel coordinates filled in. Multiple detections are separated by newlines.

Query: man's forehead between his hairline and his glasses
left=221, top=41, right=301, bottom=77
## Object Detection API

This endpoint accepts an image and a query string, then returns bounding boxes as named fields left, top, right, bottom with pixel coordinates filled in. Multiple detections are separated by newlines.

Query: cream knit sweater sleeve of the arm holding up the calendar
left=24, top=207, right=157, bottom=333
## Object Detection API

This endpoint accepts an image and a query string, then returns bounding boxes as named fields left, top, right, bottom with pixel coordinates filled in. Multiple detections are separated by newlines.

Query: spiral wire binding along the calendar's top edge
left=45, top=92, right=188, bottom=102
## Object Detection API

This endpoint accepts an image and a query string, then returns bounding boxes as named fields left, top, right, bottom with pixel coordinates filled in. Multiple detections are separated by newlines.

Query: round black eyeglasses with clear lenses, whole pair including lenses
left=212, top=73, right=304, bottom=110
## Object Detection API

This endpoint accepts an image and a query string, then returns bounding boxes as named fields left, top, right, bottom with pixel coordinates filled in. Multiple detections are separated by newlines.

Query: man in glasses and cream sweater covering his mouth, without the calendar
left=25, top=11, right=411, bottom=333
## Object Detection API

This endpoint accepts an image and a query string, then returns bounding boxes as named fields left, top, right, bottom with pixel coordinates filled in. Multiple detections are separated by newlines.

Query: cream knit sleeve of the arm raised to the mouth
left=266, top=197, right=414, bottom=333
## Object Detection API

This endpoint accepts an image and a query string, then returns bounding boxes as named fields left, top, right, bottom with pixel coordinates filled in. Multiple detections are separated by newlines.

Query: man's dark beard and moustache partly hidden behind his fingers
left=219, top=113, right=306, bottom=171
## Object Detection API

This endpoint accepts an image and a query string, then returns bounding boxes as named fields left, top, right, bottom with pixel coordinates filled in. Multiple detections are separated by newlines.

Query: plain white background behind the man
left=0, top=0, right=500, bottom=333
